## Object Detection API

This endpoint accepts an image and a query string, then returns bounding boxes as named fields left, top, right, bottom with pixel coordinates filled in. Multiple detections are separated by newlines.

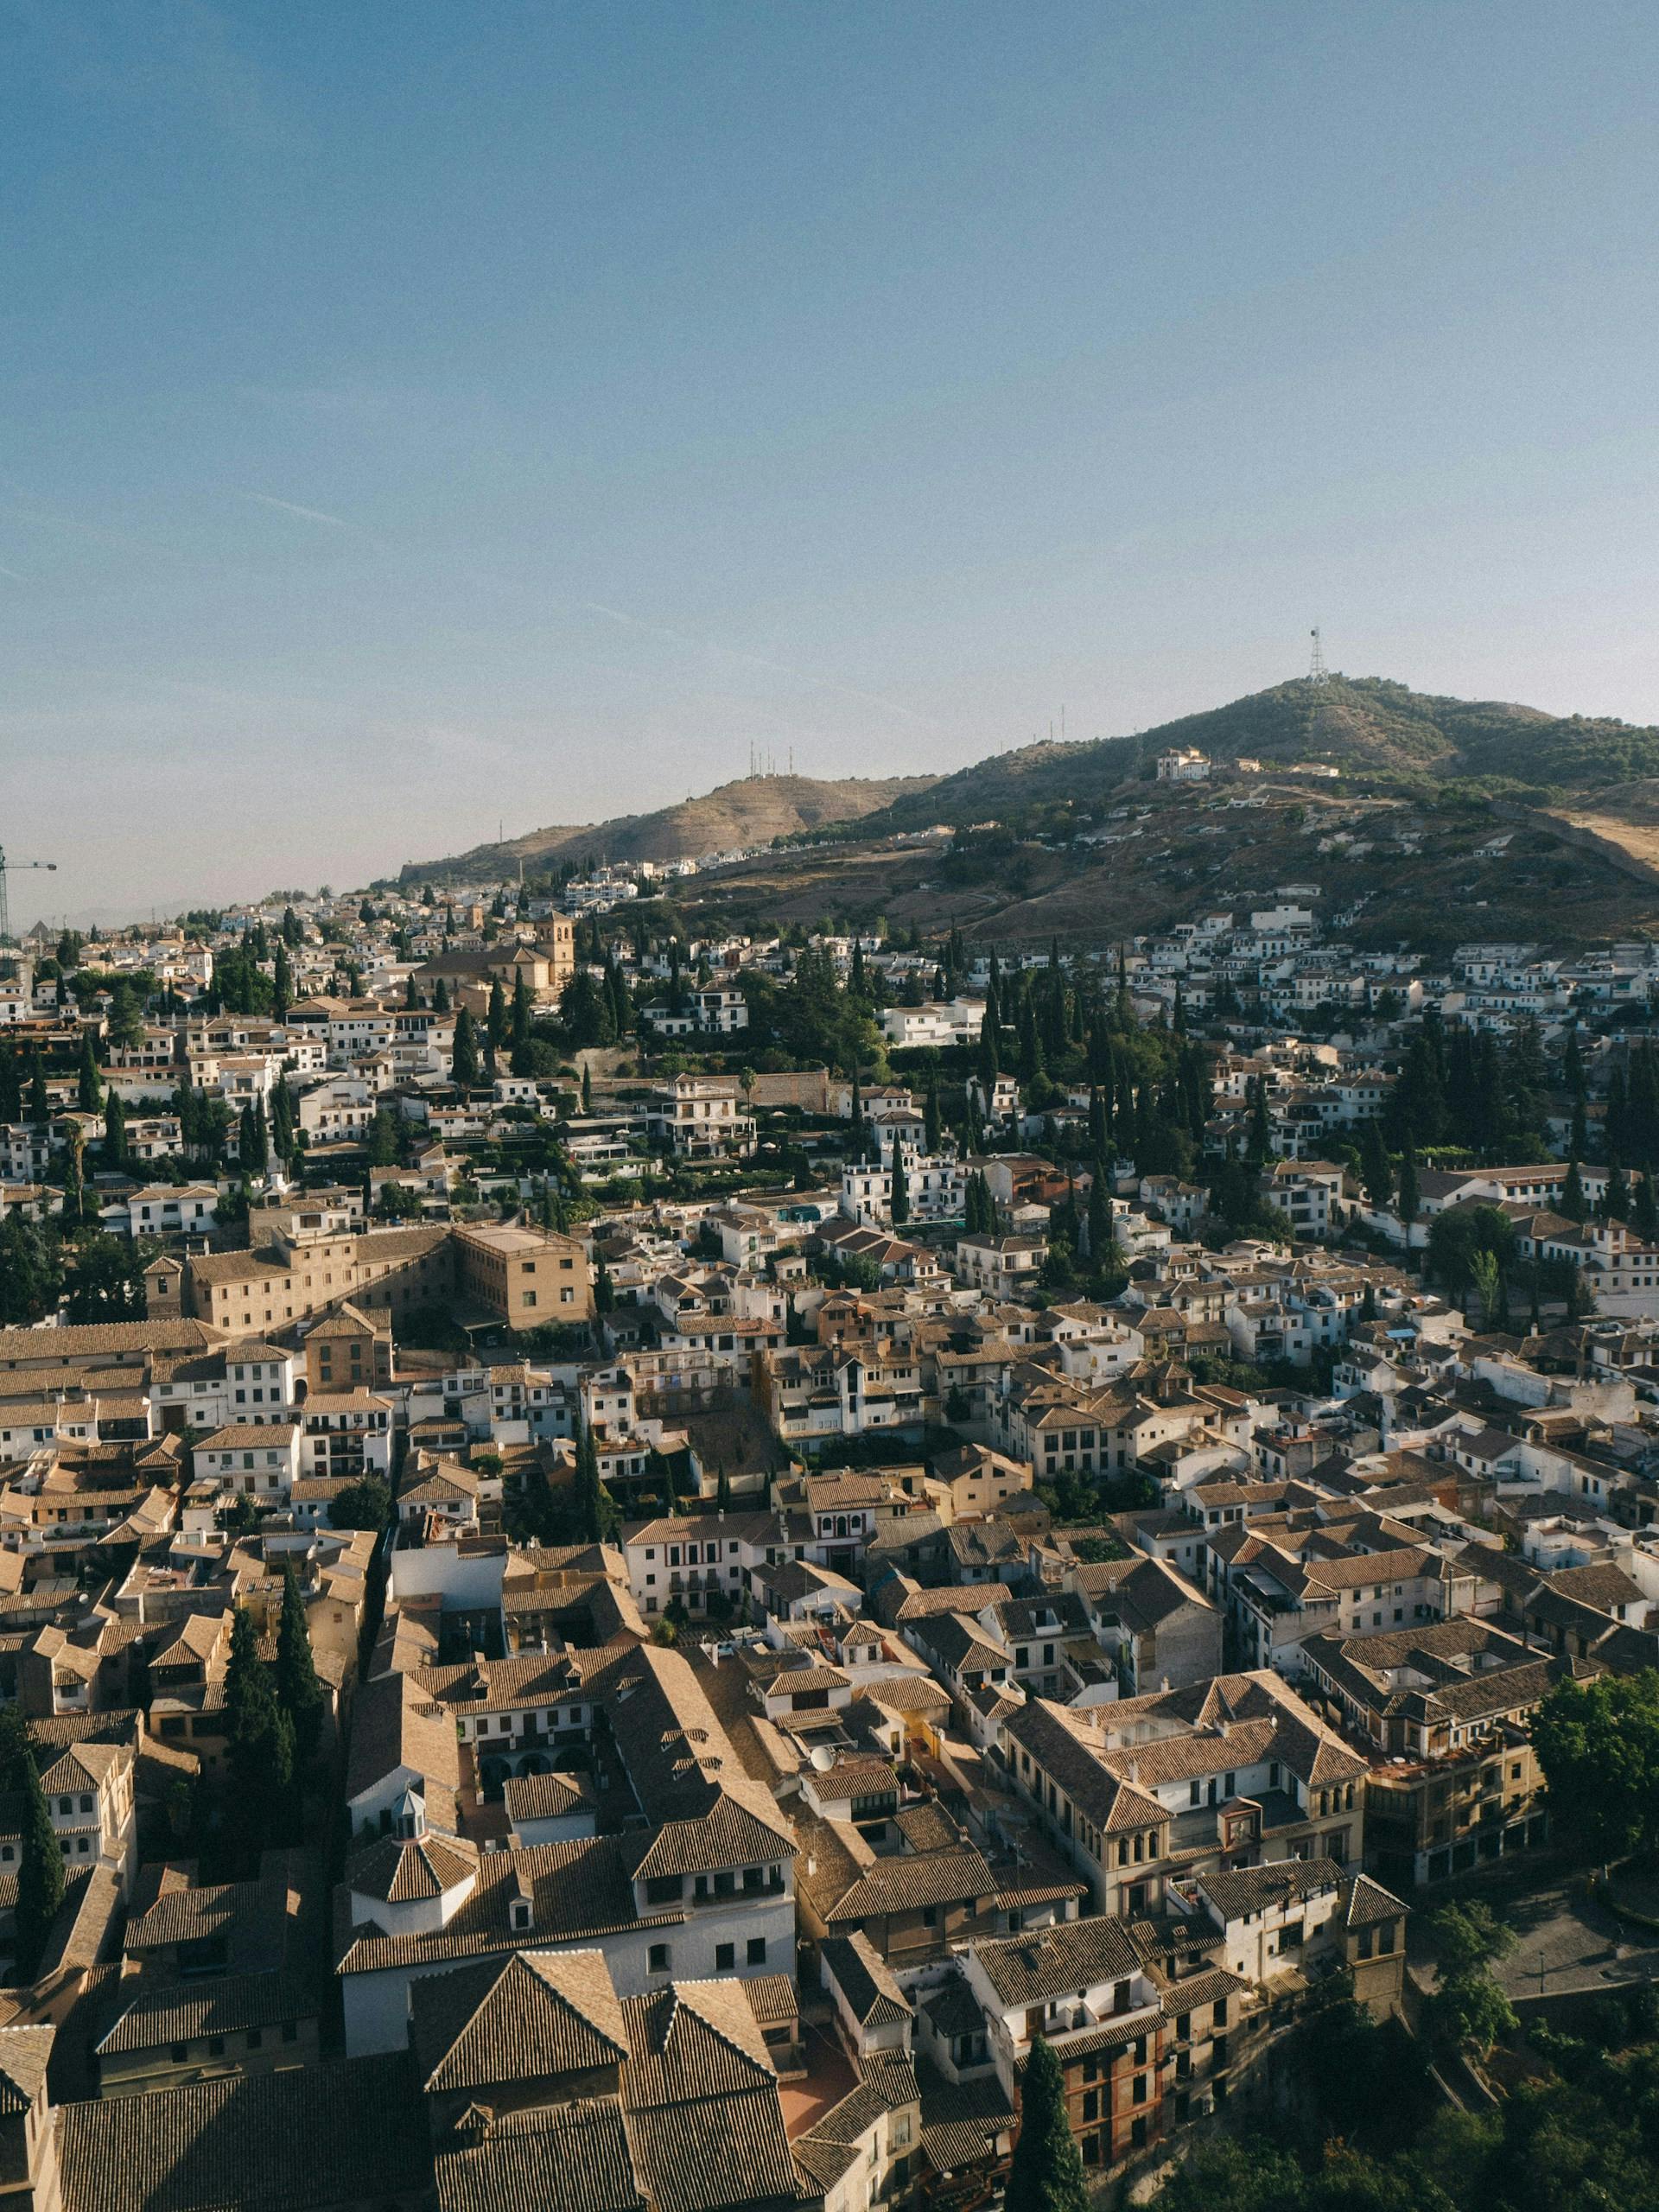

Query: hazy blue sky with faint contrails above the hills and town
left=0, top=0, right=1659, bottom=920
